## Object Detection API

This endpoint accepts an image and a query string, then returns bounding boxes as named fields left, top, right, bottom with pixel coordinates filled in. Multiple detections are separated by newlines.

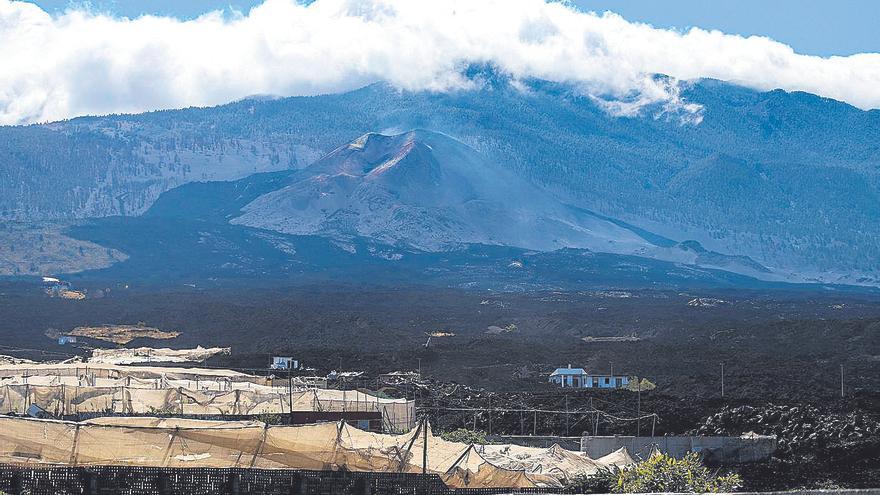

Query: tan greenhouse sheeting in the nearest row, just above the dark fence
left=0, top=417, right=544, bottom=488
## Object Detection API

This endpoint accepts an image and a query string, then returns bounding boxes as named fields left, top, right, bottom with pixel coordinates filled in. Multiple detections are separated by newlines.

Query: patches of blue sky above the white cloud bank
left=25, top=0, right=880, bottom=56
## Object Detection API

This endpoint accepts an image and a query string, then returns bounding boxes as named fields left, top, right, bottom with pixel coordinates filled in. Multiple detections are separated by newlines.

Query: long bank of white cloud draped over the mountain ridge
left=0, top=0, right=880, bottom=124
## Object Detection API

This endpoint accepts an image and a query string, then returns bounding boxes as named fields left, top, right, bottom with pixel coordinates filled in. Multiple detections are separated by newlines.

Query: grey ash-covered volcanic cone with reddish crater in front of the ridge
left=232, top=130, right=778, bottom=279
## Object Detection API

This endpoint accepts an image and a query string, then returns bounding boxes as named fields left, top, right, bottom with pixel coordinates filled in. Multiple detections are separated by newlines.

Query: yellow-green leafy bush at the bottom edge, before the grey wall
left=612, top=452, right=742, bottom=493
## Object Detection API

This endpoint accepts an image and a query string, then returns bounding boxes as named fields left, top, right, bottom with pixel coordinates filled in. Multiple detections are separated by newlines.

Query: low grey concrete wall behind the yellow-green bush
left=581, top=436, right=776, bottom=464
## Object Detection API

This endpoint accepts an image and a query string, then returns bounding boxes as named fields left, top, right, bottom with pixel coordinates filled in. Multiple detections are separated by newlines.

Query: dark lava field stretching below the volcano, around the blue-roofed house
left=0, top=282, right=880, bottom=489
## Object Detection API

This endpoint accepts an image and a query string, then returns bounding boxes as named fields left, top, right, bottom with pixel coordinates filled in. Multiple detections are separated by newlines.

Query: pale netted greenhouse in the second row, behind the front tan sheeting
left=0, top=363, right=416, bottom=433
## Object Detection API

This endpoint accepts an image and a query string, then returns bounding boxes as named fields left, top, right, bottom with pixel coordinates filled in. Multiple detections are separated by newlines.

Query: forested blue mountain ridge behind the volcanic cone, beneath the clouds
left=0, top=81, right=880, bottom=283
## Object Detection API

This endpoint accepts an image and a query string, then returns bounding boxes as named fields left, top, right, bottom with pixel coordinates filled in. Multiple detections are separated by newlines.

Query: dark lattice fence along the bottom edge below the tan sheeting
left=0, top=464, right=558, bottom=495
